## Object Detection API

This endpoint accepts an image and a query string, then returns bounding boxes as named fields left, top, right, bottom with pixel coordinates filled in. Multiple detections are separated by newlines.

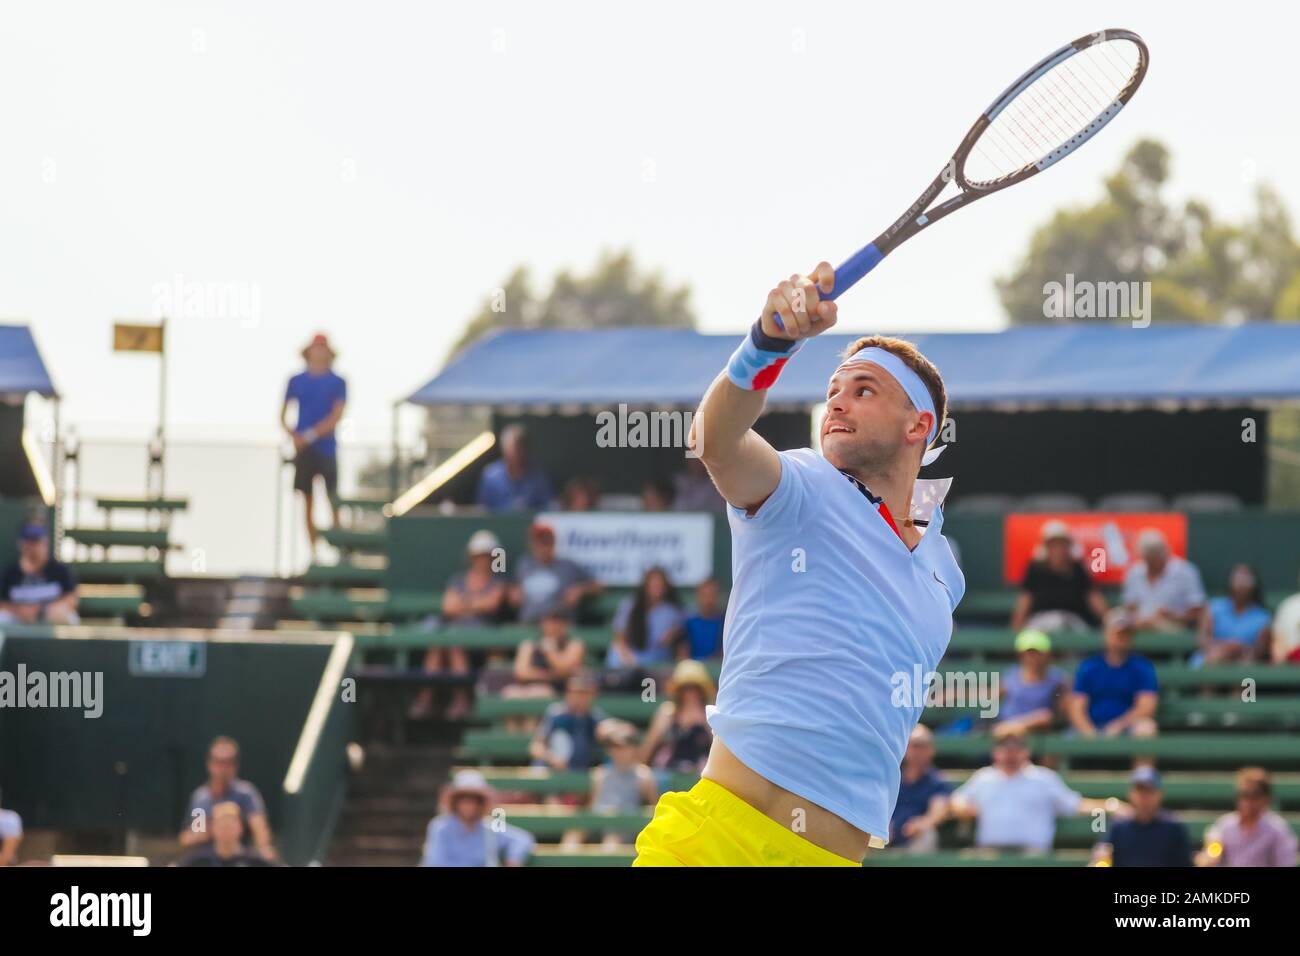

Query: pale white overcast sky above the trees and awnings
left=0, top=0, right=1300, bottom=442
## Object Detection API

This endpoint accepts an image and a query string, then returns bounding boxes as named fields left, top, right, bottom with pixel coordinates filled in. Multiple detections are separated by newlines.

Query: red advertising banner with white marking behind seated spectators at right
left=1002, top=511, right=1187, bottom=584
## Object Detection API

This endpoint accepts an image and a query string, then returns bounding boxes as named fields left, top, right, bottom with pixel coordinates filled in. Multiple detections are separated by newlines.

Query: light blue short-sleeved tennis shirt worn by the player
left=707, top=449, right=966, bottom=845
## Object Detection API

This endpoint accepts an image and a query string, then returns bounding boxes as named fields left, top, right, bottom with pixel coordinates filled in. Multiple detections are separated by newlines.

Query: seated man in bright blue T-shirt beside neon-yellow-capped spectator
left=1070, top=607, right=1158, bottom=737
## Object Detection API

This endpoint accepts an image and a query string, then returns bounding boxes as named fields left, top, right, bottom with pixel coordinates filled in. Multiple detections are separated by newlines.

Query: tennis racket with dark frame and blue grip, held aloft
left=774, top=30, right=1147, bottom=328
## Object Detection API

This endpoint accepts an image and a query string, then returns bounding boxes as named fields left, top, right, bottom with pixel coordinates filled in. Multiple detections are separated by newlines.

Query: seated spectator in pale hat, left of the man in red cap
left=408, top=529, right=507, bottom=721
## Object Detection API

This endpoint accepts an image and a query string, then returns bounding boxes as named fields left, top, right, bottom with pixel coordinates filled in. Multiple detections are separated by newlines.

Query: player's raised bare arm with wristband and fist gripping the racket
left=690, top=263, right=836, bottom=509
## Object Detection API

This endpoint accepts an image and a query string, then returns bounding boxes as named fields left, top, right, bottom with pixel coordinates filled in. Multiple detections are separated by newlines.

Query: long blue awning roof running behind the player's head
left=408, top=323, right=1300, bottom=407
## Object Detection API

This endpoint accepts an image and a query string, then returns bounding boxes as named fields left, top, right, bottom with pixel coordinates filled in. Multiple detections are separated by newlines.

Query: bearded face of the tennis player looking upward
left=822, top=363, right=918, bottom=472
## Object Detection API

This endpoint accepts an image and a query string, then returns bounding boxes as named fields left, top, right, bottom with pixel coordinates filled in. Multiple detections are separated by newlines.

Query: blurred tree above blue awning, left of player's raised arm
left=452, top=251, right=696, bottom=355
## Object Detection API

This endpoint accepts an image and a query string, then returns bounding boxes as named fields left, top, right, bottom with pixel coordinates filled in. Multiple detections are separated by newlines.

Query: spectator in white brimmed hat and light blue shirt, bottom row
left=420, top=770, right=537, bottom=866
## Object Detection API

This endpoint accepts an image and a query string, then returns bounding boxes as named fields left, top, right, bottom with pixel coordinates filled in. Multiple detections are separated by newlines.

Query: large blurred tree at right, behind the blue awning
left=996, top=139, right=1300, bottom=324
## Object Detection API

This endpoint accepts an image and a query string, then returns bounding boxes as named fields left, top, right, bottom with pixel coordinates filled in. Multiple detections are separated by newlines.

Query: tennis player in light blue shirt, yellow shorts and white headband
left=634, top=263, right=966, bottom=866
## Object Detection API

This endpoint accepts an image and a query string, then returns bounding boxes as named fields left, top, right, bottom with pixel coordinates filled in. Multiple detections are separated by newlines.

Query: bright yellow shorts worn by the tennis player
left=632, top=778, right=862, bottom=866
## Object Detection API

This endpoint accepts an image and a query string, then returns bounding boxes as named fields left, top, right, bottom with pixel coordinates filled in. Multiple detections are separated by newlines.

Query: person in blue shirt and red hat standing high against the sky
left=280, top=336, right=347, bottom=554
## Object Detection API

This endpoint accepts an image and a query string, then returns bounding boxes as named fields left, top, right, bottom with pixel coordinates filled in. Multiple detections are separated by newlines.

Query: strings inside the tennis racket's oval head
left=962, top=40, right=1141, bottom=186
